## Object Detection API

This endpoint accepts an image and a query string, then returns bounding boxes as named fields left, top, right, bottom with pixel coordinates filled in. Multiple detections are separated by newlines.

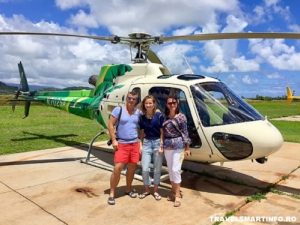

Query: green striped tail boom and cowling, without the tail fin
left=33, top=64, right=132, bottom=128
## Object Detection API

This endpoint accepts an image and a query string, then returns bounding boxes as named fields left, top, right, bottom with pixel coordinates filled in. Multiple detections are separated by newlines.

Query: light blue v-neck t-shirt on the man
left=111, top=106, right=141, bottom=143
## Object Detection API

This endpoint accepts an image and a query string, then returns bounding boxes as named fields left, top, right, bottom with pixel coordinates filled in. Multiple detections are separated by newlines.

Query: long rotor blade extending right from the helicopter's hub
left=161, top=32, right=300, bottom=42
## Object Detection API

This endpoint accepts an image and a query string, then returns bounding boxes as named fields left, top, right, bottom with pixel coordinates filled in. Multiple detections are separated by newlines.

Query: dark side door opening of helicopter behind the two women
left=149, top=87, right=202, bottom=148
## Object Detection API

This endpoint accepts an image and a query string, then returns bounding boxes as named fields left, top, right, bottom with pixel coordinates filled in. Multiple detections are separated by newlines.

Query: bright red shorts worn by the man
left=114, top=142, right=141, bottom=163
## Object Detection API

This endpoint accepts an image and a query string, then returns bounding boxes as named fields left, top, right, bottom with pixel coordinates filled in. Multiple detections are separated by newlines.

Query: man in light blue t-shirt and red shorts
left=107, top=92, right=140, bottom=205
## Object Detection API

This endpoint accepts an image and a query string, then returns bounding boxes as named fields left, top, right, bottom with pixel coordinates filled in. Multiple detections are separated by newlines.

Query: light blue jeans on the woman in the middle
left=142, top=139, right=163, bottom=186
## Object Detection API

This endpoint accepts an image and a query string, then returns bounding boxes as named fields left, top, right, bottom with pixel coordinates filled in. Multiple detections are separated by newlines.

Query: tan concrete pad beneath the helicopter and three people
left=0, top=143, right=300, bottom=225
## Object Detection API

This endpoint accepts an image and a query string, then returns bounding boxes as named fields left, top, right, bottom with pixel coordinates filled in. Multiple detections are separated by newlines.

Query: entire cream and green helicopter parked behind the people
left=0, top=32, right=300, bottom=163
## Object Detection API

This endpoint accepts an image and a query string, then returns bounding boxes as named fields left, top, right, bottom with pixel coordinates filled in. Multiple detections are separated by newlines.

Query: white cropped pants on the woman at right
left=164, top=149, right=184, bottom=184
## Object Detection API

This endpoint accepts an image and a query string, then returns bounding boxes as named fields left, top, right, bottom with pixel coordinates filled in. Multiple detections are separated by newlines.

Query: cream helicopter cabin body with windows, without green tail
left=99, top=63, right=283, bottom=163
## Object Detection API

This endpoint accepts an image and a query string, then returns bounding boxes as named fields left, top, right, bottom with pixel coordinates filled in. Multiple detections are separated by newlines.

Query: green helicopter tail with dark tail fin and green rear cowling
left=11, top=62, right=132, bottom=128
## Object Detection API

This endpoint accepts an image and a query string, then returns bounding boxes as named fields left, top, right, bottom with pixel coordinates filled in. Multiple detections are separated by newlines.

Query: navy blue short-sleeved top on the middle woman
left=139, top=112, right=164, bottom=140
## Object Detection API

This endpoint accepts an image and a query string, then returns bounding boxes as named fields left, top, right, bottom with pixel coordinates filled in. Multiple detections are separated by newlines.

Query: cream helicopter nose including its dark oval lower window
left=211, top=120, right=283, bottom=160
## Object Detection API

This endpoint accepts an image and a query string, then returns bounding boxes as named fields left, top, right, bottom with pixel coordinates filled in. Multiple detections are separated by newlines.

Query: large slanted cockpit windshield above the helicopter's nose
left=191, top=82, right=264, bottom=127
